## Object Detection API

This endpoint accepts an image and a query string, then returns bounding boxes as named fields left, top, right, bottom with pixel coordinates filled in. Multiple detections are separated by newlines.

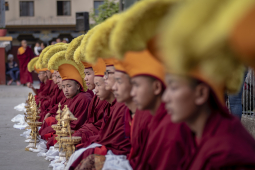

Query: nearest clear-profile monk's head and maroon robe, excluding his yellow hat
left=163, top=74, right=255, bottom=170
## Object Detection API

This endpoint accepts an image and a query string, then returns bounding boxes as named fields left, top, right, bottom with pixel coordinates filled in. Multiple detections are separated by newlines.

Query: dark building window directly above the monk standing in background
left=19, top=1, right=34, bottom=17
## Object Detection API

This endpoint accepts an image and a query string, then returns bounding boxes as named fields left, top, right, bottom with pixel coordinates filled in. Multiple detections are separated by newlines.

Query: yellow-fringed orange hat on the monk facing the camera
left=48, top=51, right=87, bottom=91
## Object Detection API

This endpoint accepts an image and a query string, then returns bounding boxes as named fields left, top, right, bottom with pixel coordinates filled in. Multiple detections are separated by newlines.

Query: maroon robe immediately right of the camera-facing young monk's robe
left=73, top=95, right=108, bottom=143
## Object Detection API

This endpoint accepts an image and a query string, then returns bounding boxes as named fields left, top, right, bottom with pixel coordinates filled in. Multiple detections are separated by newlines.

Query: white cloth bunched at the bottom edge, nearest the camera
left=102, top=150, right=133, bottom=170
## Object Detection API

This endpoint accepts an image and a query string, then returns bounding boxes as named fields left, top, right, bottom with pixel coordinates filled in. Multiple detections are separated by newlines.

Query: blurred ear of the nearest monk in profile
left=195, top=83, right=210, bottom=105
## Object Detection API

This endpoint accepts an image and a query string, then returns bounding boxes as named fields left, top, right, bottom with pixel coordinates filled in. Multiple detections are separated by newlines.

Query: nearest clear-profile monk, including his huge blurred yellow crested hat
left=160, top=0, right=255, bottom=167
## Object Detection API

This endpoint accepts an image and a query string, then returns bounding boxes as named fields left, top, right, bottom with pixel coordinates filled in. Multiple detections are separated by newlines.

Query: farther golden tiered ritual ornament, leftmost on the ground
left=24, top=93, right=42, bottom=151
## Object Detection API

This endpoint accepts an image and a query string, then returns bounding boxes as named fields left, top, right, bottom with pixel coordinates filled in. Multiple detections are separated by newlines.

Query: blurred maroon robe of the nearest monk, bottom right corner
left=179, top=92, right=255, bottom=170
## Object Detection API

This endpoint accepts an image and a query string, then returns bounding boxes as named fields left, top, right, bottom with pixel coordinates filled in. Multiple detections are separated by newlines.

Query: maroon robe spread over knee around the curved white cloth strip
left=70, top=99, right=131, bottom=169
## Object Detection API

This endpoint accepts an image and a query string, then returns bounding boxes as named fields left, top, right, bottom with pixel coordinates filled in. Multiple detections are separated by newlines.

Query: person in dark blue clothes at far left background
left=6, top=54, right=20, bottom=86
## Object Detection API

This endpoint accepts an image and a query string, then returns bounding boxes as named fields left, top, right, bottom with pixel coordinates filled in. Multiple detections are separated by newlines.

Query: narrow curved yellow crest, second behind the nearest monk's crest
left=85, top=14, right=120, bottom=63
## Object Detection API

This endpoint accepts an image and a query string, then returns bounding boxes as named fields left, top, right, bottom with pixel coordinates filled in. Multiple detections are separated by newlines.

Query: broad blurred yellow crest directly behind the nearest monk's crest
left=110, top=0, right=180, bottom=59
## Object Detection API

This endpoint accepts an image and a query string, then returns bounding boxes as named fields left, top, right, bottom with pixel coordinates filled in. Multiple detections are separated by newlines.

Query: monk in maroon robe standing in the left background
left=17, top=40, right=34, bottom=87
